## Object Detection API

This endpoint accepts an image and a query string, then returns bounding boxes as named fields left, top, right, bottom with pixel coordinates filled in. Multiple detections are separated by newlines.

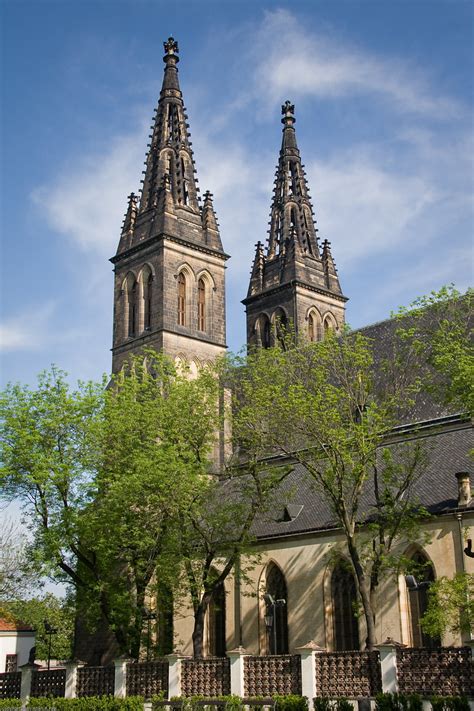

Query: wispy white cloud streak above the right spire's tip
left=254, top=9, right=462, bottom=118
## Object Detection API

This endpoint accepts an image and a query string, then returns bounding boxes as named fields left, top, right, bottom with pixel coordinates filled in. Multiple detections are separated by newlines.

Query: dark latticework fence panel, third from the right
left=244, top=654, right=301, bottom=696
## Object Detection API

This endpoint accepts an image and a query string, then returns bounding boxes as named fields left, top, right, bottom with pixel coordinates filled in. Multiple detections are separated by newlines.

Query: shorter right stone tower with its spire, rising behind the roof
left=242, top=101, right=347, bottom=347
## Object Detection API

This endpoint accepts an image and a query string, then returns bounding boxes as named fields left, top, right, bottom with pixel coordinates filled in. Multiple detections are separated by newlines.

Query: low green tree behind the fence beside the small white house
left=0, top=593, right=75, bottom=659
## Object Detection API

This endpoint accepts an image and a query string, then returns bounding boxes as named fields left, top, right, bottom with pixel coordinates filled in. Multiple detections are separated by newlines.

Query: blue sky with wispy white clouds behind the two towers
left=0, top=0, right=474, bottom=385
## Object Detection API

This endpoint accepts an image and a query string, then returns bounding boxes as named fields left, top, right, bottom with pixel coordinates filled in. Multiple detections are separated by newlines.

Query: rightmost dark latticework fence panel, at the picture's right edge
left=397, top=647, right=474, bottom=696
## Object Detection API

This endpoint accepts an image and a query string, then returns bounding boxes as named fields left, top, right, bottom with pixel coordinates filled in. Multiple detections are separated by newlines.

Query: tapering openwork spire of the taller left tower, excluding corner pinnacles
left=139, top=37, right=200, bottom=214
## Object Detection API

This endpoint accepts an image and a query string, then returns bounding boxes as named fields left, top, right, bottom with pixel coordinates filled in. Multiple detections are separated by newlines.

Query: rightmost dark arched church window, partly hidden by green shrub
left=408, top=552, right=441, bottom=649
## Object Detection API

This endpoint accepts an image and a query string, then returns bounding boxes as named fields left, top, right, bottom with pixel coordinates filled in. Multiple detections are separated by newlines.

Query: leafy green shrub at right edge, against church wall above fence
left=421, top=573, right=474, bottom=637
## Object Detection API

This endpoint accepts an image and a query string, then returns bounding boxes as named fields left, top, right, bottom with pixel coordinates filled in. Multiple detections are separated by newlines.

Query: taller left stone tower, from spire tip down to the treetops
left=111, top=37, right=228, bottom=372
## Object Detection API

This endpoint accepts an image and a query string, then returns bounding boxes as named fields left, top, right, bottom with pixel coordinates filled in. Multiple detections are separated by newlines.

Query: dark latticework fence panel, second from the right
left=316, top=652, right=382, bottom=698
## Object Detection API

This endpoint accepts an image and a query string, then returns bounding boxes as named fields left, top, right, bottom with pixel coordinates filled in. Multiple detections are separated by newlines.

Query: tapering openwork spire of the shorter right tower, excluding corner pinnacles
left=267, top=101, right=320, bottom=260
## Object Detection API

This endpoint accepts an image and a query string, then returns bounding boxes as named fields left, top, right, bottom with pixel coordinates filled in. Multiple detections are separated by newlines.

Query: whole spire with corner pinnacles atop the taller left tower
left=117, top=37, right=223, bottom=254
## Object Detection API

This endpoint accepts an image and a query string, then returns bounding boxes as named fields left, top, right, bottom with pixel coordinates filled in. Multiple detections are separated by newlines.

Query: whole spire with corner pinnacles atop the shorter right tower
left=247, top=101, right=342, bottom=298
